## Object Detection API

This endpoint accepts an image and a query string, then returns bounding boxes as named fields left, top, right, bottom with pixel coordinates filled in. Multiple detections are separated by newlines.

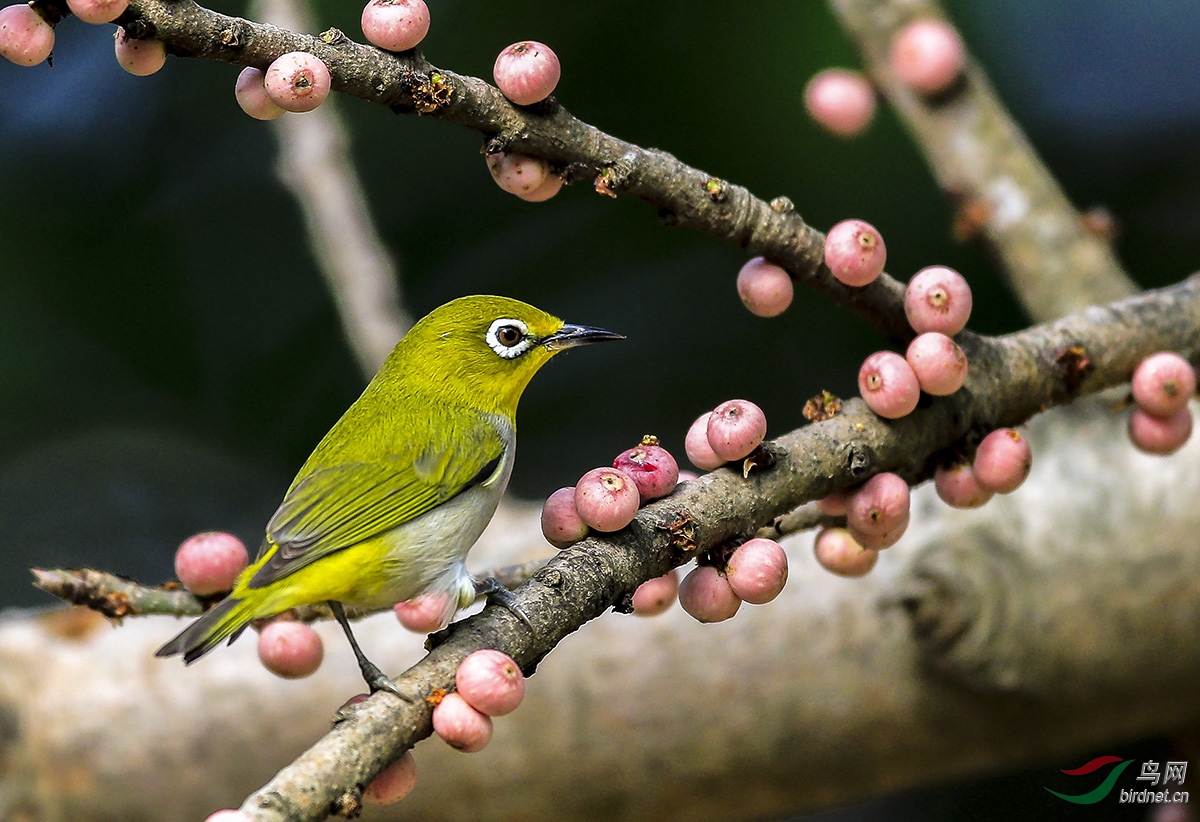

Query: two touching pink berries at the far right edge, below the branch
left=1129, top=352, right=1196, bottom=455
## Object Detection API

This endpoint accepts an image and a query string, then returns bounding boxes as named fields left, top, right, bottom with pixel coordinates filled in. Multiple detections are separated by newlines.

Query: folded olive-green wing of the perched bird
left=248, top=425, right=505, bottom=588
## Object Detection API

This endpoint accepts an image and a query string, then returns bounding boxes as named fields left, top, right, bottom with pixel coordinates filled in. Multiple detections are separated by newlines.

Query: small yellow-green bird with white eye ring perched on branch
left=157, top=296, right=624, bottom=694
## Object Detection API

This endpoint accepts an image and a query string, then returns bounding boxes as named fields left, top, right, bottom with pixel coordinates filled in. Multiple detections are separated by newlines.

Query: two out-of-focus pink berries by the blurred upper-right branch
left=804, top=18, right=966, bottom=137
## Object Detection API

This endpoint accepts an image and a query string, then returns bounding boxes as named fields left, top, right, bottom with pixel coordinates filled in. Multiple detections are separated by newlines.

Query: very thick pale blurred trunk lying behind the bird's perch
left=7, top=398, right=1200, bottom=822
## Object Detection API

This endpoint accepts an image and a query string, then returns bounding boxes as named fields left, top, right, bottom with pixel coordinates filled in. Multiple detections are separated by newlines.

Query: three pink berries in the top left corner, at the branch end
left=0, top=0, right=167, bottom=77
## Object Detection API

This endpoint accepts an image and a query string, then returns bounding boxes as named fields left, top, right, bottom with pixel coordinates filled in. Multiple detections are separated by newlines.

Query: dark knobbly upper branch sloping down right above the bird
left=98, top=0, right=912, bottom=340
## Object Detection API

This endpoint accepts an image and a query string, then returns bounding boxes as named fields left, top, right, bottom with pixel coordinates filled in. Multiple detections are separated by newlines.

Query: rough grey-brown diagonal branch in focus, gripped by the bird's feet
left=234, top=276, right=1200, bottom=820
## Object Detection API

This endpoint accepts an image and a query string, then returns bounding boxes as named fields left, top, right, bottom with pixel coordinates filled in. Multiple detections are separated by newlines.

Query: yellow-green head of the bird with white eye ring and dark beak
left=384, top=296, right=624, bottom=415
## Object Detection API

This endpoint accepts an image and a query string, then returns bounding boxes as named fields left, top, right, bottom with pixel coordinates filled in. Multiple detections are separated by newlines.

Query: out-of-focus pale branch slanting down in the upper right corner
left=832, top=0, right=1136, bottom=322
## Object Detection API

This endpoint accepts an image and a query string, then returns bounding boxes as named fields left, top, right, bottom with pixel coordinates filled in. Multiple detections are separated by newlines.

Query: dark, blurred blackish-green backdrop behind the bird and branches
left=0, top=0, right=1200, bottom=818
